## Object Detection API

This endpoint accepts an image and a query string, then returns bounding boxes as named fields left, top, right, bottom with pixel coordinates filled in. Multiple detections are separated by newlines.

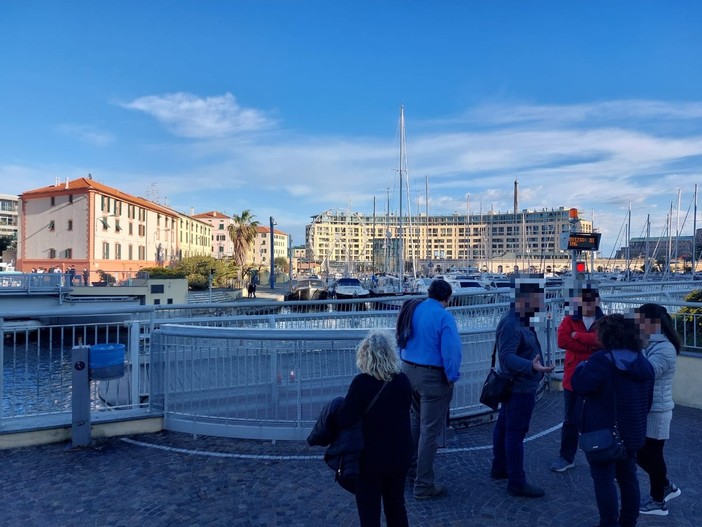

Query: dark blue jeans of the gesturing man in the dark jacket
left=492, top=392, right=536, bottom=489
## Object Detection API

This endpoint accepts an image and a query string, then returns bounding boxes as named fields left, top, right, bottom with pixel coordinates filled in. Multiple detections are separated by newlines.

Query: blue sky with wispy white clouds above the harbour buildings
left=0, top=0, right=702, bottom=257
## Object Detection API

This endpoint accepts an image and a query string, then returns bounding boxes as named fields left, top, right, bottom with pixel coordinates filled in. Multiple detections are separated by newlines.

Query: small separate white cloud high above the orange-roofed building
left=121, top=93, right=275, bottom=138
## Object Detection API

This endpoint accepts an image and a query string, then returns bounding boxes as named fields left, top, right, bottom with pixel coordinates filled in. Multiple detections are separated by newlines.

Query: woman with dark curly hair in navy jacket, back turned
left=571, top=313, right=654, bottom=527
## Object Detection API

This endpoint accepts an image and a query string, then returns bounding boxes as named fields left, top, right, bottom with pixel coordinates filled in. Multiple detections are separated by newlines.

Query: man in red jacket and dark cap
left=551, top=284, right=604, bottom=472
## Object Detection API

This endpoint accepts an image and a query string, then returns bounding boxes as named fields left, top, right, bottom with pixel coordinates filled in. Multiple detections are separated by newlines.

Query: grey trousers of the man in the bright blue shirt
left=402, top=363, right=453, bottom=494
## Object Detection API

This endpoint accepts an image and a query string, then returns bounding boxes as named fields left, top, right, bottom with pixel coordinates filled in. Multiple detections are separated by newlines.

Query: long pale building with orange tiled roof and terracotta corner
left=17, top=178, right=211, bottom=281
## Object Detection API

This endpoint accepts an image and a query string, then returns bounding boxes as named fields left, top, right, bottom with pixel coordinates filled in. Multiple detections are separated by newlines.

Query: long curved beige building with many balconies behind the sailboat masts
left=305, top=207, right=592, bottom=273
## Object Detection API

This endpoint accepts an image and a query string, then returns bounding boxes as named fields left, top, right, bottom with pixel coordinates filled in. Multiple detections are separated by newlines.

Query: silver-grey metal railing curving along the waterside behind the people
left=0, top=283, right=702, bottom=438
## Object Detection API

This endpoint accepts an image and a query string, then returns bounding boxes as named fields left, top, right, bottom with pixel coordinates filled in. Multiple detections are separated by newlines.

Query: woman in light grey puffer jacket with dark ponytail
left=636, top=304, right=682, bottom=516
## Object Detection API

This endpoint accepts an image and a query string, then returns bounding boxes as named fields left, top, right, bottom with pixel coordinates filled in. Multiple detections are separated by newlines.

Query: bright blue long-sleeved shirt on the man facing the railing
left=400, top=298, right=462, bottom=382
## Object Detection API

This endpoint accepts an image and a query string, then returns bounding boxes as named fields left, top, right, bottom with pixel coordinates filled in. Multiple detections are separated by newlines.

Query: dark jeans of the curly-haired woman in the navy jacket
left=590, top=448, right=641, bottom=527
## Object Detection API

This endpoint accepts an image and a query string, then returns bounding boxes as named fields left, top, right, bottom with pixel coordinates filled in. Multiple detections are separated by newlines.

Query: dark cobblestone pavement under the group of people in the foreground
left=0, top=393, right=702, bottom=527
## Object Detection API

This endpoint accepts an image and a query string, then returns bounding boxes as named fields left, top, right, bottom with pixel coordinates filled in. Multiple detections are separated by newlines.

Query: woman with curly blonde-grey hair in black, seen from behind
left=335, top=331, right=412, bottom=527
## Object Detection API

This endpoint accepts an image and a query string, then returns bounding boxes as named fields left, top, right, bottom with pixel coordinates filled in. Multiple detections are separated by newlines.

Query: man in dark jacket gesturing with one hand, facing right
left=490, top=280, right=553, bottom=498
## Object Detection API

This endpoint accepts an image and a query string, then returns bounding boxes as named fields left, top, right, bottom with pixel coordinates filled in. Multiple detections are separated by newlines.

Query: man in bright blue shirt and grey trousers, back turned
left=400, top=279, right=462, bottom=500
